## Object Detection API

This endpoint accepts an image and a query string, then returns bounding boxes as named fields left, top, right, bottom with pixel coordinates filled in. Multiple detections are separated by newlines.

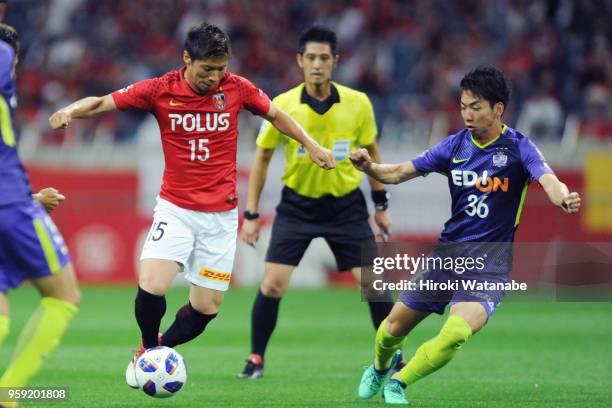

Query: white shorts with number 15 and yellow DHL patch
left=140, top=197, right=238, bottom=291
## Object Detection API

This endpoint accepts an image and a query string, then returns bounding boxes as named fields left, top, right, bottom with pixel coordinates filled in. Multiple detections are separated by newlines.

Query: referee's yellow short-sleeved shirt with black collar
left=257, top=83, right=377, bottom=198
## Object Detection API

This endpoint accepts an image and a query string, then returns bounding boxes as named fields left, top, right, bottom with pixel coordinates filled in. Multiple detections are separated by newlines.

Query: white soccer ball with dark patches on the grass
left=135, top=346, right=187, bottom=398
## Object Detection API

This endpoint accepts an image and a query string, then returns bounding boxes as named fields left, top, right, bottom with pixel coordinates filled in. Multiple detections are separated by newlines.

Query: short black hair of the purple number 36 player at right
left=460, top=65, right=510, bottom=107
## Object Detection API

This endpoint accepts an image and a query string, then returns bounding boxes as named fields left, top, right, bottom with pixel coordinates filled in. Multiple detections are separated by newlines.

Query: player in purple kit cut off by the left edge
left=0, top=23, right=80, bottom=407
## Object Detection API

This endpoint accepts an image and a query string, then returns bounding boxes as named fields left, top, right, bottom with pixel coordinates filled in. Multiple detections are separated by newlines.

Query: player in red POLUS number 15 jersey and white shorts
left=49, top=23, right=335, bottom=387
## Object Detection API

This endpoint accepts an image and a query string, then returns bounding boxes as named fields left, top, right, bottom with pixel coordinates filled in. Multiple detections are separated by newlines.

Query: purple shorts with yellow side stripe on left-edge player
left=0, top=200, right=70, bottom=292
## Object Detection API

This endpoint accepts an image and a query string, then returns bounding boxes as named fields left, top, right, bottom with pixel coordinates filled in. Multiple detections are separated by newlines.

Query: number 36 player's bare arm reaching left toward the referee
left=349, top=148, right=421, bottom=184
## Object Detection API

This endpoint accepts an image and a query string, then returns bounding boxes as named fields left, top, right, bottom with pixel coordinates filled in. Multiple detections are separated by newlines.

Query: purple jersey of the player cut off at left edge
left=0, top=41, right=32, bottom=205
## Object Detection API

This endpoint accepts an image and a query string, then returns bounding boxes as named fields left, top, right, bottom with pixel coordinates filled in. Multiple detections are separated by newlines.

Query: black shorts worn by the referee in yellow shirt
left=266, top=186, right=375, bottom=271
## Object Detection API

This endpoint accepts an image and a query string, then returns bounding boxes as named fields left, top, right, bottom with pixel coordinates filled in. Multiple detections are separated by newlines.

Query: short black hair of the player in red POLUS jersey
left=185, top=23, right=232, bottom=60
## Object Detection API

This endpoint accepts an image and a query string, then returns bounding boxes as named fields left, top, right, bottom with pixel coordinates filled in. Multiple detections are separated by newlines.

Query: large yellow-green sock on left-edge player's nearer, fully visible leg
left=0, top=297, right=78, bottom=387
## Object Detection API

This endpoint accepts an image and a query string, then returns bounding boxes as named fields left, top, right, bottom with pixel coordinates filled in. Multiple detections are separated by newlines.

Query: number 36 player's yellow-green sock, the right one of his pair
left=391, top=316, right=472, bottom=385
